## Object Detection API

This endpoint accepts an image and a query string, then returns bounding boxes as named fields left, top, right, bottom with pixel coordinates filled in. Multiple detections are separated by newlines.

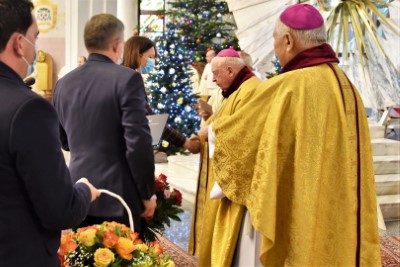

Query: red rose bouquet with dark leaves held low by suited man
left=143, top=173, right=183, bottom=242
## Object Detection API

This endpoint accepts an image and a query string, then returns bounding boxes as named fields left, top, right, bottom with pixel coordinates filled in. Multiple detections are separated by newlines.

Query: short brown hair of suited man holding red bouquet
left=83, top=14, right=124, bottom=50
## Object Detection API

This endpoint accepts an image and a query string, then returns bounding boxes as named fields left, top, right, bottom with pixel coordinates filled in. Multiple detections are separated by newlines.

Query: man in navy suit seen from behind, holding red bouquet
left=53, top=14, right=156, bottom=236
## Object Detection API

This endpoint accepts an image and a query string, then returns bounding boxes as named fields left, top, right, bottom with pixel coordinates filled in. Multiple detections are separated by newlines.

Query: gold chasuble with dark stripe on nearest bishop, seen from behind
left=213, top=64, right=381, bottom=267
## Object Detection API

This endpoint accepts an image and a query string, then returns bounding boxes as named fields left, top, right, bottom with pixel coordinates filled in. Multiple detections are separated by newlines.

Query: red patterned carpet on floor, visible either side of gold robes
left=160, top=236, right=400, bottom=267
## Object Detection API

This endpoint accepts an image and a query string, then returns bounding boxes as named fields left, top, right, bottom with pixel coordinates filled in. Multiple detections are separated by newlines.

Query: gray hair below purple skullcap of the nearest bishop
left=275, top=18, right=327, bottom=47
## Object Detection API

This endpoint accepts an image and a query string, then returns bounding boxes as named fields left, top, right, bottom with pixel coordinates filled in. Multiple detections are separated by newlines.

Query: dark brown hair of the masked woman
left=122, top=36, right=156, bottom=70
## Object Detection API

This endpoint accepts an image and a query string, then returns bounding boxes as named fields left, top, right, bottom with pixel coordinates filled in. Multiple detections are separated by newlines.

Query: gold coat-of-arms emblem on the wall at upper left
left=33, top=0, right=57, bottom=33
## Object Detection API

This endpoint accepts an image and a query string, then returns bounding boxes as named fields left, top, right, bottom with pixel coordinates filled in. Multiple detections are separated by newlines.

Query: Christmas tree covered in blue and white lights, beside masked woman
left=147, top=22, right=200, bottom=155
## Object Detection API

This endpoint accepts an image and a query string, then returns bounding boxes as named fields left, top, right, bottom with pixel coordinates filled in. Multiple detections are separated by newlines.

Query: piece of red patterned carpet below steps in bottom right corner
left=381, top=236, right=400, bottom=267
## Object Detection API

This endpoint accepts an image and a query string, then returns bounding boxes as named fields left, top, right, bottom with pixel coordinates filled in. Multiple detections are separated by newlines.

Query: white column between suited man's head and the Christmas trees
left=117, top=0, right=139, bottom=40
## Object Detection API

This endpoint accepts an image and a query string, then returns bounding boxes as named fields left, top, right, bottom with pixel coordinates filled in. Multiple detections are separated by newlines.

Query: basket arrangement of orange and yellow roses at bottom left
left=58, top=222, right=175, bottom=267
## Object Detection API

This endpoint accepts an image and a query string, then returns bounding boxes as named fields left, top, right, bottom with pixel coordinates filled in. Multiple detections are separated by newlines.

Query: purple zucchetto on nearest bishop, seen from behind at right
left=279, top=4, right=324, bottom=30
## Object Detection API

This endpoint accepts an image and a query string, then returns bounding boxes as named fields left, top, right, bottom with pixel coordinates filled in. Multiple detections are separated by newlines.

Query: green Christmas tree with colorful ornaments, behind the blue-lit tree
left=168, top=0, right=239, bottom=61
